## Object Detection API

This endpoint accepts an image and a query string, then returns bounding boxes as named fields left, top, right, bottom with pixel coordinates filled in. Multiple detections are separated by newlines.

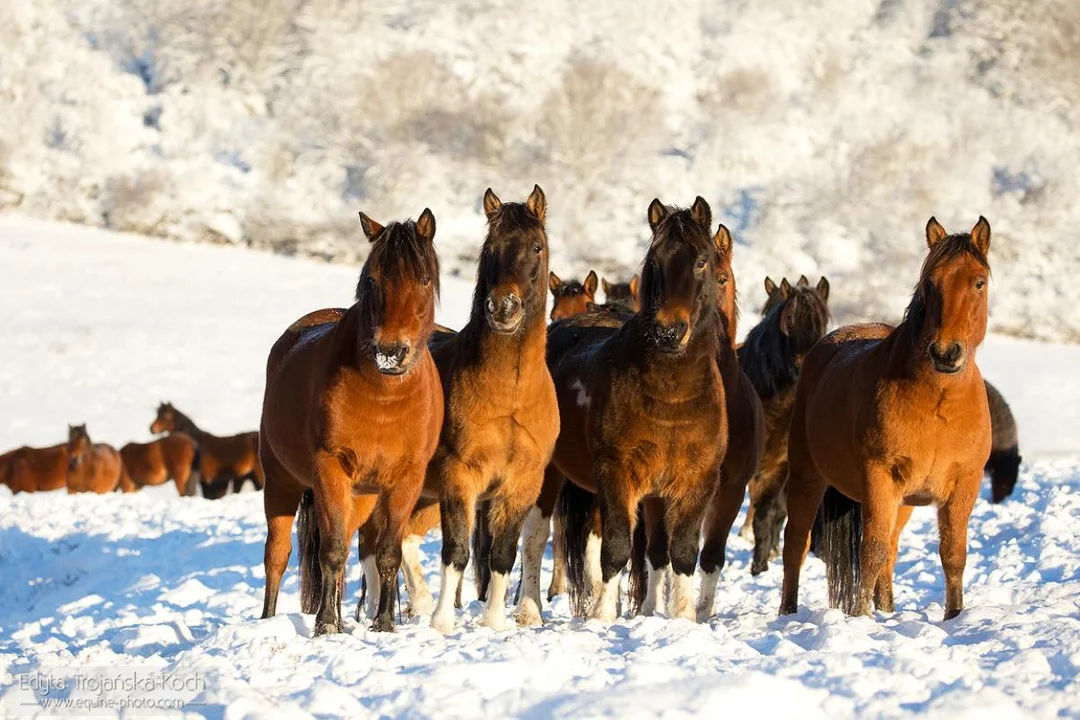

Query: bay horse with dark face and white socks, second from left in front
left=424, top=186, right=559, bottom=633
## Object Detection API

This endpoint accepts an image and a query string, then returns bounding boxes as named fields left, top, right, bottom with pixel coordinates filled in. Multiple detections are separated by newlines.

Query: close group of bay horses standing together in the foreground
left=243, top=187, right=1020, bottom=635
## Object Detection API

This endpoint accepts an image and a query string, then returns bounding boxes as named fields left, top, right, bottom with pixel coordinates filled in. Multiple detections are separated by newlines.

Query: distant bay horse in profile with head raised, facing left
left=150, top=403, right=264, bottom=500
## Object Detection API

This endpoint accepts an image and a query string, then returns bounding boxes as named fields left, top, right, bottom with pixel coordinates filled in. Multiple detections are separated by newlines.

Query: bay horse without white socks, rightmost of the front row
left=780, top=217, right=991, bottom=620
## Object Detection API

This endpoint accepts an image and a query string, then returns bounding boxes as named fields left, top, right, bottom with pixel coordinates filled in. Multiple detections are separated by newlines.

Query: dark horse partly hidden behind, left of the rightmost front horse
left=739, top=276, right=829, bottom=575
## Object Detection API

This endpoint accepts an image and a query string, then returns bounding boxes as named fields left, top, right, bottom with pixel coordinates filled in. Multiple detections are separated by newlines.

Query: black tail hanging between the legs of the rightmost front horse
left=818, top=488, right=863, bottom=614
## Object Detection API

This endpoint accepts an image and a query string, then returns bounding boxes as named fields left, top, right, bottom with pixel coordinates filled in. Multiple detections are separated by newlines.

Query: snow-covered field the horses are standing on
left=0, top=217, right=1080, bottom=718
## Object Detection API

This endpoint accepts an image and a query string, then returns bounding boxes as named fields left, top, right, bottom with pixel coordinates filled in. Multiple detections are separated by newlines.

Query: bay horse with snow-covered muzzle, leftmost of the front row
left=259, top=209, right=443, bottom=636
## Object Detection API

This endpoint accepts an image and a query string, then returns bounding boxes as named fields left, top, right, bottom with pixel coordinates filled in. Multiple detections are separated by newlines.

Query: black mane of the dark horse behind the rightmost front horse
left=738, top=288, right=829, bottom=399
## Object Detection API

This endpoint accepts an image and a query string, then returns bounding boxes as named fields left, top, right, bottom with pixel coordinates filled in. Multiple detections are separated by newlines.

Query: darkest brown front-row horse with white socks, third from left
left=549, top=198, right=728, bottom=622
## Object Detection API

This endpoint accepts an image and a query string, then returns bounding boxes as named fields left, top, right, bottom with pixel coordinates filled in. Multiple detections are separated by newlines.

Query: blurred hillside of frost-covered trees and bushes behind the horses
left=0, top=0, right=1080, bottom=341
